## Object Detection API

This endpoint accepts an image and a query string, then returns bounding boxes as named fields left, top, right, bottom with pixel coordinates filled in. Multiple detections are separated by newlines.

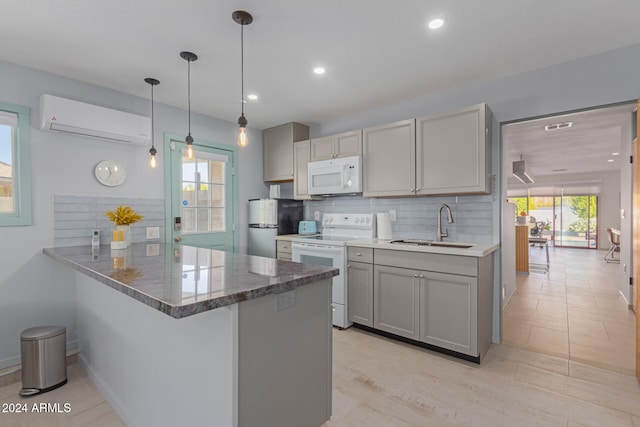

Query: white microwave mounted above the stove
left=307, top=156, right=362, bottom=195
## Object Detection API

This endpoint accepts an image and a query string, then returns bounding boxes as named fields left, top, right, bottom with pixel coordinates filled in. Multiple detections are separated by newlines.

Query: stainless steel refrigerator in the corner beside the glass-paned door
left=248, top=199, right=304, bottom=258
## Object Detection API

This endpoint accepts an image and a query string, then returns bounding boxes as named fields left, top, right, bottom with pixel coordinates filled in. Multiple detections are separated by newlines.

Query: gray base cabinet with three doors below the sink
left=348, top=247, right=493, bottom=361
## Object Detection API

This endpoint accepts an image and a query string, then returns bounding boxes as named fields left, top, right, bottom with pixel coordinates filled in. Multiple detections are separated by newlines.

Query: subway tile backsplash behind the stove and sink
left=304, top=195, right=493, bottom=243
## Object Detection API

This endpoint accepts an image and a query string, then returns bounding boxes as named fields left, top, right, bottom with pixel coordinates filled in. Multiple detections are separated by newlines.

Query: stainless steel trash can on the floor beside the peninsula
left=20, top=326, right=67, bottom=396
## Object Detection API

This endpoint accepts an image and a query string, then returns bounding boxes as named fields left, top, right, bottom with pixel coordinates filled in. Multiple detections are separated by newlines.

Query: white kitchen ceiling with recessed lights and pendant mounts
left=0, top=0, right=640, bottom=129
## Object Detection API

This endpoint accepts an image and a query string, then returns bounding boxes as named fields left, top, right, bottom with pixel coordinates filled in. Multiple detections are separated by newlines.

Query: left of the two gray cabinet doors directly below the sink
left=373, top=265, right=420, bottom=340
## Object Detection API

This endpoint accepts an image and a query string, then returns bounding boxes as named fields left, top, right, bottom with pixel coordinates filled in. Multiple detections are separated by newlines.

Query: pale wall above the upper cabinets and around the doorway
left=310, top=44, right=640, bottom=340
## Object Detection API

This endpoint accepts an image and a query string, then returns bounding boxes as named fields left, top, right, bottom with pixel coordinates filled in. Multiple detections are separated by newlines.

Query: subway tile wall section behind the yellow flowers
left=53, top=196, right=165, bottom=247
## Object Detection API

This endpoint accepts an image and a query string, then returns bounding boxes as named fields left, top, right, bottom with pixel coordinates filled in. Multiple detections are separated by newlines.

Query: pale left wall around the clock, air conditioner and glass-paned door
left=0, top=62, right=268, bottom=368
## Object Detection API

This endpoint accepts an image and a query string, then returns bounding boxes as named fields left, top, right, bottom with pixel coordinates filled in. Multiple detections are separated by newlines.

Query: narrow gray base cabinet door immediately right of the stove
left=347, top=262, right=373, bottom=327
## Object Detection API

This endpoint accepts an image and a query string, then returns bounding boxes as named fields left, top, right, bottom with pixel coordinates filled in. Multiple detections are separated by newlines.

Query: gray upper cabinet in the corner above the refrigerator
left=262, top=122, right=309, bottom=181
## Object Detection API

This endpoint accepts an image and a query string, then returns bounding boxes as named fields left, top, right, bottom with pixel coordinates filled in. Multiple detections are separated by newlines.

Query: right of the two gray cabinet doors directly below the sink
left=419, top=272, right=478, bottom=356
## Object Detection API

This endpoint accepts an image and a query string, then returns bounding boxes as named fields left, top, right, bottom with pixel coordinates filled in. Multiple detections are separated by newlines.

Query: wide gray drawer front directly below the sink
left=374, top=249, right=478, bottom=277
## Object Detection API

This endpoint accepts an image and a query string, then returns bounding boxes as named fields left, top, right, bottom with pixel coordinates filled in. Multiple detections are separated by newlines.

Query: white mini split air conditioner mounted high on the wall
left=40, top=95, right=151, bottom=144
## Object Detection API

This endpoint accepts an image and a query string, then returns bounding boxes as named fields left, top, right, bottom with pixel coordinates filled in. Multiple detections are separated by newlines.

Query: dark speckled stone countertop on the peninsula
left=43, top=243, right=338, bottom=319
